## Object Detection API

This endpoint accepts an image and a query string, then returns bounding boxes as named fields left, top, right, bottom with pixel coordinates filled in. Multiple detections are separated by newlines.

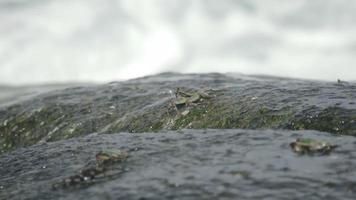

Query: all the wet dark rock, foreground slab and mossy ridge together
left=0, top=73, right=356, bottom=199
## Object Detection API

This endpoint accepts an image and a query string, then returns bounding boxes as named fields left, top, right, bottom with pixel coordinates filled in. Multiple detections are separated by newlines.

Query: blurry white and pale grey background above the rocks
left=0, top=0, right=356, bottom=85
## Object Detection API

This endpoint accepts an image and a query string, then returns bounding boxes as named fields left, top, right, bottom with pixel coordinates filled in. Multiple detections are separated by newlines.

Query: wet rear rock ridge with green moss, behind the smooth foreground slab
left=0, top=73, right=356, bottom=153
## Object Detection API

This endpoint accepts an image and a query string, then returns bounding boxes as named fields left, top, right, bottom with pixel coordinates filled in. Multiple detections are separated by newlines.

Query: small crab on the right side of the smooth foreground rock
left=290, top=138, right=337, bottom=155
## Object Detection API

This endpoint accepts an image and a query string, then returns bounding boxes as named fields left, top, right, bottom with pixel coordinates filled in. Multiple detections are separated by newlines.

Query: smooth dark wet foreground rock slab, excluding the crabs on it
left=0, top=129, right=356, bottom=199
